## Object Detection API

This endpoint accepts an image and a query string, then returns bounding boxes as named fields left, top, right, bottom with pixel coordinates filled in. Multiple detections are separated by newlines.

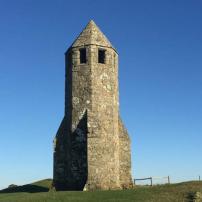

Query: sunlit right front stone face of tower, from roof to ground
left=87, top=45, right=120, bottom=189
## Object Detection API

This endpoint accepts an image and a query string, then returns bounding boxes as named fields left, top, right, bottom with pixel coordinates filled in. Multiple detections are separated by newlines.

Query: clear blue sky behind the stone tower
left=0, top=0, right=202, bottom=188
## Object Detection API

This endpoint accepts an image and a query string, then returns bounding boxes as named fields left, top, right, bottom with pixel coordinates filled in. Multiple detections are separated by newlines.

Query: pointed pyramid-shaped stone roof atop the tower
left=71, top=20, right=114, bottom=49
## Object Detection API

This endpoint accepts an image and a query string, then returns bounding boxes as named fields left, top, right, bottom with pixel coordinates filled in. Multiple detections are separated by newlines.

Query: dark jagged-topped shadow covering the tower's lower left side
left=54, top=111, right=88, bottom=191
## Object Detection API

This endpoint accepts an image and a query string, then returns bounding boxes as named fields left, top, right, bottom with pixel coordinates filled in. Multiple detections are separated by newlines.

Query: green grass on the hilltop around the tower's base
left=0, top=179, right=202, bottom=202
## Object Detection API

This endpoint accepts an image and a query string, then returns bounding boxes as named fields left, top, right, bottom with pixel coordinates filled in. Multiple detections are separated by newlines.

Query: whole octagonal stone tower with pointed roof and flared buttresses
left=53, top=20, right=132, bottom=190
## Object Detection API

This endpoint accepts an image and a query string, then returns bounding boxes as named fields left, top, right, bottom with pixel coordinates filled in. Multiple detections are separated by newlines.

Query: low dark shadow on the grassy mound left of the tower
left=0, top=184, right=49, bottom=194
